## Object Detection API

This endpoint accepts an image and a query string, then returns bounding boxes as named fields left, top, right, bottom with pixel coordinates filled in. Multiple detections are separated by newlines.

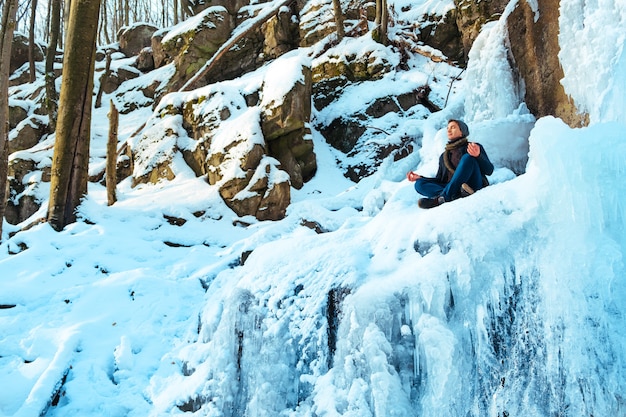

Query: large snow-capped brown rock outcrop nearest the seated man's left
left=129, top=56, right=317, bottom=220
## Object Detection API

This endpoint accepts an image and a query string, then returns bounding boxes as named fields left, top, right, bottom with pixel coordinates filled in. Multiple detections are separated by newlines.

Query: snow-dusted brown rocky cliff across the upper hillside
left=7, top=0, right=586, bottom=224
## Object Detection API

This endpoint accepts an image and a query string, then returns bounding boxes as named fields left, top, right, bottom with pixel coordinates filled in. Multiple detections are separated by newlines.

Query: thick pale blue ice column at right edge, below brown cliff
left=529, top=119, right=626, bottom=415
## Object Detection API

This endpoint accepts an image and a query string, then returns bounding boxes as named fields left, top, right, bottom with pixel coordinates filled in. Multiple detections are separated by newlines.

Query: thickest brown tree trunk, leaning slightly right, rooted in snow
left=48, top=0, right=100, bottom=231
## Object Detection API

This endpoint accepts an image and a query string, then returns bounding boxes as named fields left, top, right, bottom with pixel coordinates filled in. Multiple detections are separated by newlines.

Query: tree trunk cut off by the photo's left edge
left=0, top=0, right=17, bottom=241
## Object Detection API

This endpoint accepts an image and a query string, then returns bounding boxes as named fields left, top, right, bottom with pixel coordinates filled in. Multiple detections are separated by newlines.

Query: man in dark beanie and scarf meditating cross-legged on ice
left=406, top=119, right=493, bottom=208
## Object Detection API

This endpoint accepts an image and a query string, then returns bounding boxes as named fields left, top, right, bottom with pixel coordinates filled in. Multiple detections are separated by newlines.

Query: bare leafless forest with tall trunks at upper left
left=0, top=0, right=222, bottom=235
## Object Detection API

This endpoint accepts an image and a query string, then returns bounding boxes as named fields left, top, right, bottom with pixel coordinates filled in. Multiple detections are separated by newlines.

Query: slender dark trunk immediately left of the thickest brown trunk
left=45, top=0, right=61, bottom=132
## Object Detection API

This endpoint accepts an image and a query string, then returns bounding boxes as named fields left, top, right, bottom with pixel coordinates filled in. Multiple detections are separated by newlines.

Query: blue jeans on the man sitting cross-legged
left=415, top=154, right=483, bottom=201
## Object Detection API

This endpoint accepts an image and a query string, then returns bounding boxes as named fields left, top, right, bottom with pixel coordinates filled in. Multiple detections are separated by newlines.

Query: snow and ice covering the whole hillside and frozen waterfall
left=0, top=0, right=626, bottom=417
